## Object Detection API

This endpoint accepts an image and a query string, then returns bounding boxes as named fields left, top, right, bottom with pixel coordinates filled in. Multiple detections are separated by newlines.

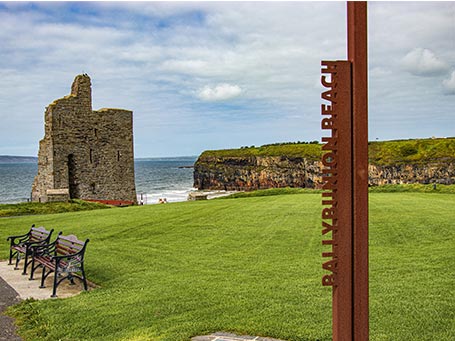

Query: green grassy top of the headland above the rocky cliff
left=201, top=138, right=455, bottom=166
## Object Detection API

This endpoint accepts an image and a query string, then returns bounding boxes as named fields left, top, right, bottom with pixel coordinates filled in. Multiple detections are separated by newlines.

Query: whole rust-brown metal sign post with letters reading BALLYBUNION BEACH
left=321, top=2, right=369, bottom=341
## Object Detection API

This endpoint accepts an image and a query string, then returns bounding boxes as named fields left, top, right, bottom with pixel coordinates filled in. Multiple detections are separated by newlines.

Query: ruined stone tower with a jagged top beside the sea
left=32, top=74, right=137, bottom=203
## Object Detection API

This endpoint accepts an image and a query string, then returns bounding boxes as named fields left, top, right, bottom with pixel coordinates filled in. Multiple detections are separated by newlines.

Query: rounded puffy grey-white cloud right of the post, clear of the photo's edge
left=402, top=47, right=448, bottom=76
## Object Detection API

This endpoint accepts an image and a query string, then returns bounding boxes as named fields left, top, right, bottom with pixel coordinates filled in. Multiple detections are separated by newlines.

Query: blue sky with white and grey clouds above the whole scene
left=0, top=2, right=455, bottom=157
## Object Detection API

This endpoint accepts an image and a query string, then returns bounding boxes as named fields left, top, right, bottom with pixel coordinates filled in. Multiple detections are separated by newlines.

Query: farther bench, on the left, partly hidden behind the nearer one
left=6, top=224, right=54, bottom=275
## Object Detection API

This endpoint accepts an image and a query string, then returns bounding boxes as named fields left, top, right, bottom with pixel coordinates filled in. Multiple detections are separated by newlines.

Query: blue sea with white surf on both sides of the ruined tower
left=0, top=156, right=197, bottom=204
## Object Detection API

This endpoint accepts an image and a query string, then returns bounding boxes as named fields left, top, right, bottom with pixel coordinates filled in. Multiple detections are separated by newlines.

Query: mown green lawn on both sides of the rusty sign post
left=0, top=193, right=455, bottom=341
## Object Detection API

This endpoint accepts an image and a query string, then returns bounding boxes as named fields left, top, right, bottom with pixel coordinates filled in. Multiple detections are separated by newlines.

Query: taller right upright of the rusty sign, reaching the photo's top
left=347, top=1, right=369, bottom=341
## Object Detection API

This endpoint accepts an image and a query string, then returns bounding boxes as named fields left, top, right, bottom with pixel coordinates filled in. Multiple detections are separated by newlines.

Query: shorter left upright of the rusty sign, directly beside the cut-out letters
left=332, top=61, right=354, bottom=341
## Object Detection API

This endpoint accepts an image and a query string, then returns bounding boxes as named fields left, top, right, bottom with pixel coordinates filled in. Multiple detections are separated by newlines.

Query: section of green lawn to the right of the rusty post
left=370, top=193, right=455, bottom=340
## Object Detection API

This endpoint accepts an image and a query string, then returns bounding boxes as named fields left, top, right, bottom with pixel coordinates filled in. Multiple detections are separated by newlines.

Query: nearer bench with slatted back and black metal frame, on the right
left=30, top=235, right=89, bottom=297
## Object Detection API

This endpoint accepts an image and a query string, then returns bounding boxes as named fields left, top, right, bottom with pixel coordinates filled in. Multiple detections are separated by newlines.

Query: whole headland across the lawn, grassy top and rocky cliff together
left=194, top=138, right=455, bottom=191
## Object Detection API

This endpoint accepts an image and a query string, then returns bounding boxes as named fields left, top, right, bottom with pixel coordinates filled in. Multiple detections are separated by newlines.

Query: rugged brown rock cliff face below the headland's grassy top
left=194, top=155, right=455, bottom=191
